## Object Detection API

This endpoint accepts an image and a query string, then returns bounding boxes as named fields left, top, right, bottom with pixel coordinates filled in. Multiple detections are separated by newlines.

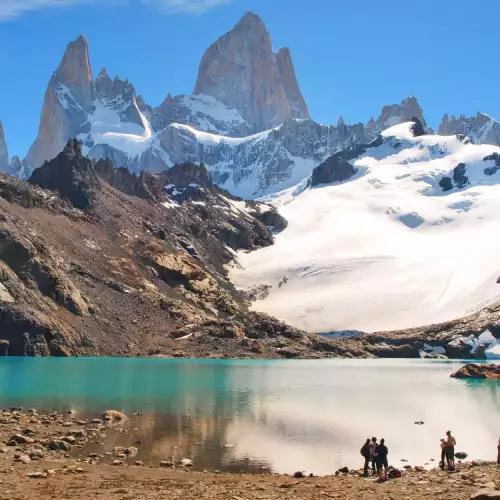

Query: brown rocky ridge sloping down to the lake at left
left=0, top=140, right=356, bottom=358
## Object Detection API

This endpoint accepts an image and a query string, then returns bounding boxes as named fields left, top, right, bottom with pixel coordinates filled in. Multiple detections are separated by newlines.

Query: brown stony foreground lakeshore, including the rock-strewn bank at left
left=0, top=410, right=500, bottom=500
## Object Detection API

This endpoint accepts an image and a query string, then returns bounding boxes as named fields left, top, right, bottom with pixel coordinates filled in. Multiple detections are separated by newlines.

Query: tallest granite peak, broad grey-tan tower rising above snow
left=194, top=12, right=308, bottom=131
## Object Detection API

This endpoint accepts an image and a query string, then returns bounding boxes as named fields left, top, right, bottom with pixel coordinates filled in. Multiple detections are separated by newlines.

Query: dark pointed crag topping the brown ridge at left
left=29, top=139, right=100, bottom=210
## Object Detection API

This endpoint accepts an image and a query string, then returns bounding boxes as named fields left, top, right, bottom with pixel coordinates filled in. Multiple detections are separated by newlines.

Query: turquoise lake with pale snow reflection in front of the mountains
left=0, top=357, right=500, bottom=475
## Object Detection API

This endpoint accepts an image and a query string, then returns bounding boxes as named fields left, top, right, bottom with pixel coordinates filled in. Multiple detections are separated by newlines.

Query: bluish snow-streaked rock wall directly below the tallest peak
left=151, top=119, right=370, bottom=199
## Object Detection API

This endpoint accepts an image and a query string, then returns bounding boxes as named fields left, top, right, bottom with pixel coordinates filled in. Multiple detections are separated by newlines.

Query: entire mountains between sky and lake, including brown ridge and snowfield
left=0, top=13, right=500, bottom=357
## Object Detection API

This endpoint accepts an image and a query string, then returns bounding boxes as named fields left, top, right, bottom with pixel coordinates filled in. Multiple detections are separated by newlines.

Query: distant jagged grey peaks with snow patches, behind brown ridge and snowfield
left=0, top=12, right=500, bottom=199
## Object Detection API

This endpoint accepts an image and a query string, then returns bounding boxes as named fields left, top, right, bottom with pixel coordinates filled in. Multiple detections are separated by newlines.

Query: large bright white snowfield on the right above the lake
left=231, top=123, right=500, bottom=332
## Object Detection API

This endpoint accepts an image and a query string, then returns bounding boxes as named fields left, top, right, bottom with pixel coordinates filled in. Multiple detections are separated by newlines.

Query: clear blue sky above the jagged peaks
left=0, top=0, right=500, bottom=157
